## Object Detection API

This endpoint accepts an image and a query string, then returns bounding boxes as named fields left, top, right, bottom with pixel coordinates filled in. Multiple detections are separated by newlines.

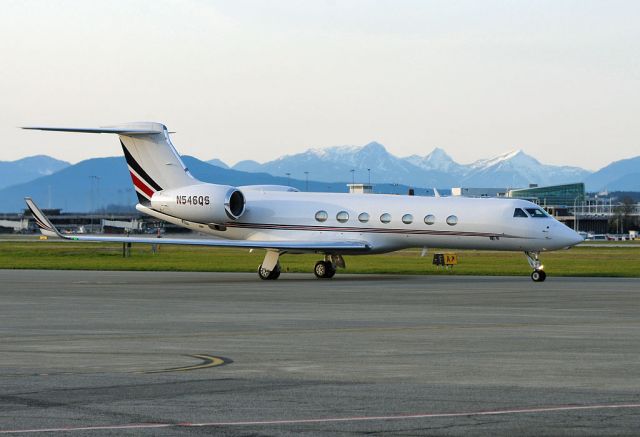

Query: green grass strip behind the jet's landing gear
left=0, top=240, right=640, bottom=277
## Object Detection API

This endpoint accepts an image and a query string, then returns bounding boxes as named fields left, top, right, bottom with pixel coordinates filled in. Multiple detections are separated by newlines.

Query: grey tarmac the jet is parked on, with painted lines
left=0, top=270, right=640, bottom=436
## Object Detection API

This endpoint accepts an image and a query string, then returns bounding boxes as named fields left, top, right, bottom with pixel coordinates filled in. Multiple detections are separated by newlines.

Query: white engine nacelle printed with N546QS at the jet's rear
left=151, top=184, right=245, bottom=225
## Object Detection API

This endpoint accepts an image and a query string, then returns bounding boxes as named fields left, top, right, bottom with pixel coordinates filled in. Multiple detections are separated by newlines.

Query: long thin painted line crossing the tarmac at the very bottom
left=0, top=403, right=640, bottom=434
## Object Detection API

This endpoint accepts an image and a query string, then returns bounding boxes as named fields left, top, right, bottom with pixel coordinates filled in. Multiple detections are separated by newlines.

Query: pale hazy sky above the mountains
left=0, top=0, right=640, bottom=170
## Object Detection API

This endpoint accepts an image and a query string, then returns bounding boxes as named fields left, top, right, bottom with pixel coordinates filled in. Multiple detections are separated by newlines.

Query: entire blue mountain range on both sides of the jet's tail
left=0, top=142, right=640, bottom=212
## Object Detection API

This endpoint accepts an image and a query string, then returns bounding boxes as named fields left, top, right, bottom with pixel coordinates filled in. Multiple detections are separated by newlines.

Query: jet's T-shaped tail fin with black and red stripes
left=23, top=122, right=197, bottom=205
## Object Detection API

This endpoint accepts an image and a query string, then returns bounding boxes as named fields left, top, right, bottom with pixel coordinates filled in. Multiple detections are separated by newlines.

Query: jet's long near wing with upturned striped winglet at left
left=25, top=197, right=371, bottom=252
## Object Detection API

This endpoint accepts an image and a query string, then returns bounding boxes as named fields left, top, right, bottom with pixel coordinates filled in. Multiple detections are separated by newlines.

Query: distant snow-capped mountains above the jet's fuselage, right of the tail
left=208, top=142, right=640, bottom=191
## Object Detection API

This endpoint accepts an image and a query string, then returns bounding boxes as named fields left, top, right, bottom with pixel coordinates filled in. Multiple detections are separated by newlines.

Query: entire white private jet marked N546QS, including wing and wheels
left=24, top=122, right=583, bottom=282
